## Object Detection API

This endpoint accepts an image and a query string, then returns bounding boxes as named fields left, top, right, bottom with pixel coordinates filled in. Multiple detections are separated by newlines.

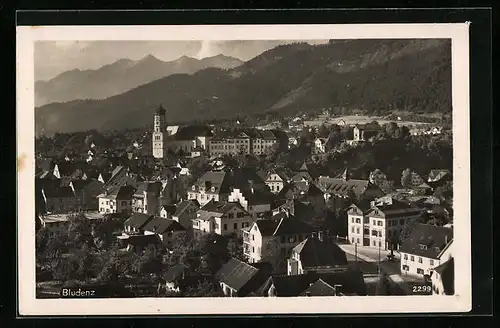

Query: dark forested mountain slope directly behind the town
left=35, top=39, right=451, bottom=135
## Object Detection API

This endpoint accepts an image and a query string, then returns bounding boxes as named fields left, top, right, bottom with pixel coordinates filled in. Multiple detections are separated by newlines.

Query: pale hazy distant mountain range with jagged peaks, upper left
left=35, top=55, right=243, bottom=106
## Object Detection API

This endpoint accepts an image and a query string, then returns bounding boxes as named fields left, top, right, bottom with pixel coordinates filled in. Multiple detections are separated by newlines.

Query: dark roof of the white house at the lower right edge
left=399, top=224, right=453, bottom=259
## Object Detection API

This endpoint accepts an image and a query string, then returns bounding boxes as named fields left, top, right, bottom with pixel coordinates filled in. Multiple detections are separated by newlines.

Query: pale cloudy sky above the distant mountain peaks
left=35, top=40, right=328, bottom=81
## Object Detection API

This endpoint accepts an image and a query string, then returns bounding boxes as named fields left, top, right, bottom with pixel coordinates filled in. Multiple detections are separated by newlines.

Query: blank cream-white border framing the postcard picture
left=16, top=22, right=472, bottom=316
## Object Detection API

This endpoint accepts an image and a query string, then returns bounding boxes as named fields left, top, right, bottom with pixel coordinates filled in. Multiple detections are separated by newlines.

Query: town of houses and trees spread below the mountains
left=35, top=104, right=454, bottom=298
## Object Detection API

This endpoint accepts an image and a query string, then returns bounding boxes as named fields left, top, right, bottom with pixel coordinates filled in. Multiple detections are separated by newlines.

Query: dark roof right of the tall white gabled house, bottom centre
left=293, top=237, right=347, bottom=268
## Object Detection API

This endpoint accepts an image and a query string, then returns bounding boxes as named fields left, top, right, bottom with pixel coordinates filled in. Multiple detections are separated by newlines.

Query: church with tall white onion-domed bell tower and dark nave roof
left=151, top=105, right=212, bottom=159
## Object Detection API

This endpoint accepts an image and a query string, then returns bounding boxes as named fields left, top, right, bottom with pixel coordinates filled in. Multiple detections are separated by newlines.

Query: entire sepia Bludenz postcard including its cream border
left=18, top=24, right=471, bottom=314
